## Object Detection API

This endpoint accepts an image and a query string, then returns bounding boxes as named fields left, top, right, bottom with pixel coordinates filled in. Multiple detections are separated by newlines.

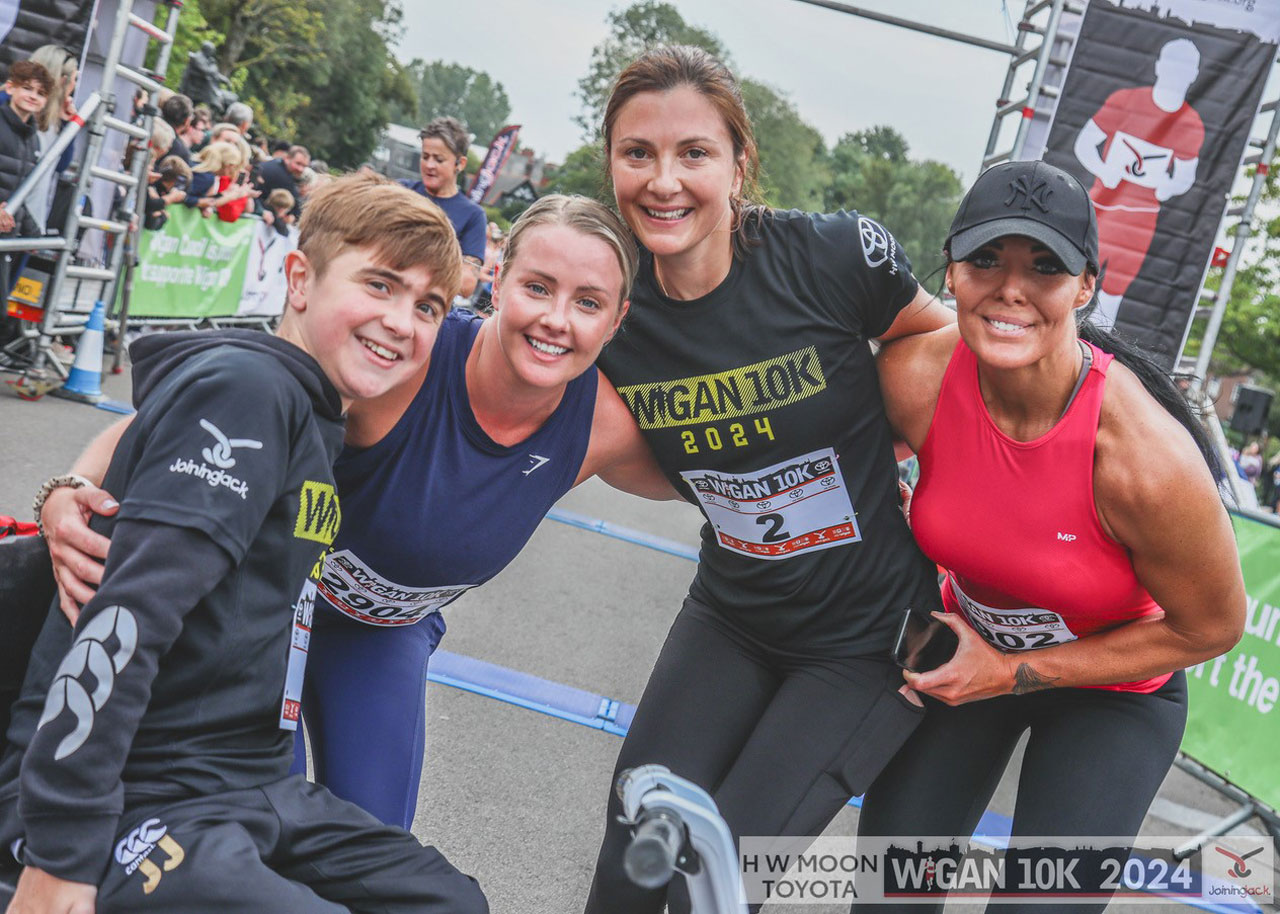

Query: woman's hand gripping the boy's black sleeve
left=40, top=485, right=120, bottom=625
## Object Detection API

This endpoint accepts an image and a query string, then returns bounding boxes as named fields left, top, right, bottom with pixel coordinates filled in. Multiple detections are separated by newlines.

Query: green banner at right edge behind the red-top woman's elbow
left=1183, top=513, right=1280, bottom=809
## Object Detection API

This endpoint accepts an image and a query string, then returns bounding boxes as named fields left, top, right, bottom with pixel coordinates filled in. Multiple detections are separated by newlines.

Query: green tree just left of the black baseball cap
left=823, top=127, right=964, bottom=279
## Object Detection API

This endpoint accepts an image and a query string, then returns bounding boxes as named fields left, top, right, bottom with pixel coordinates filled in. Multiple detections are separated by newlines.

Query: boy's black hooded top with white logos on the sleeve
left=0, top=332, right=342, bottom=882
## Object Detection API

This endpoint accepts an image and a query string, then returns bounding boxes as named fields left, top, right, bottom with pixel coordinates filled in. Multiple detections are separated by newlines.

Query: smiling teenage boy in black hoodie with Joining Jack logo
left=0, top=175, right=488, bottom=914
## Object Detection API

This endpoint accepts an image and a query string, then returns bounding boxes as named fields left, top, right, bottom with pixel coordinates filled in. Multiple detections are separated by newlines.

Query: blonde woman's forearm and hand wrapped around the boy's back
left=40, top=416, right=133, bottom=625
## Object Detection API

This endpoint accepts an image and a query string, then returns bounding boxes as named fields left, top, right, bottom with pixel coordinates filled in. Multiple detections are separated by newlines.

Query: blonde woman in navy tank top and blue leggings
left=32, top=195, right=675, bottom=828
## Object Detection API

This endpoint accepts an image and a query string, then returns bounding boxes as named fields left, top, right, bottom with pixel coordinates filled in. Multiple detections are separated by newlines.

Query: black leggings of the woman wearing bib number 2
left=586, top=598, right=923, bottom=914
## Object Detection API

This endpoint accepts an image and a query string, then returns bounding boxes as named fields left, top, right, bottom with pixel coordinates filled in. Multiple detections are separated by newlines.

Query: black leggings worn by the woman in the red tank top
left=855, top=671, right=1187, bottom=914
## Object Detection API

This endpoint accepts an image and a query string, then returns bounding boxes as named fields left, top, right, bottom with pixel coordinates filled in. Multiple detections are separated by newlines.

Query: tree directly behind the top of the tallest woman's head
left=576, top=0, right=730, bottom=135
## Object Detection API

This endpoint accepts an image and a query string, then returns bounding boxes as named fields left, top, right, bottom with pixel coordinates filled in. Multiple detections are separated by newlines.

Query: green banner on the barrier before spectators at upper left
left=129, top=205, right=259, bottom=320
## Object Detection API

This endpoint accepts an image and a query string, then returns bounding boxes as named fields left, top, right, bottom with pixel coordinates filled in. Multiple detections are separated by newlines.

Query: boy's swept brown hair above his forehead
left=298, top=172, right=462, bottom=301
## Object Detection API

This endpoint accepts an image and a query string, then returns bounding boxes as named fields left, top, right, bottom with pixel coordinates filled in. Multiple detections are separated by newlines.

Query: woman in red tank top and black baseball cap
left=859, top=161, right=1245, bottom=914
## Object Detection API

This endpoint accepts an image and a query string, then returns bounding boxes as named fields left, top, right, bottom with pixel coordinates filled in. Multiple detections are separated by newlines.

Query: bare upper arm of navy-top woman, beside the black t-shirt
left=573, top=374, right=680, bottom=501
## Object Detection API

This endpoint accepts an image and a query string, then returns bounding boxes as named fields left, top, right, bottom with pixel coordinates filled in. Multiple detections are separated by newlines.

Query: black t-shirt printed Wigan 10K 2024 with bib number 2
left=599, top=211, right=929, bottom=655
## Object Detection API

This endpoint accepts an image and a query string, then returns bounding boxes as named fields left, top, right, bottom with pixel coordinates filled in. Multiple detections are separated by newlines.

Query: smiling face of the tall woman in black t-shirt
left=609, top=86, right=744, bottom=271
